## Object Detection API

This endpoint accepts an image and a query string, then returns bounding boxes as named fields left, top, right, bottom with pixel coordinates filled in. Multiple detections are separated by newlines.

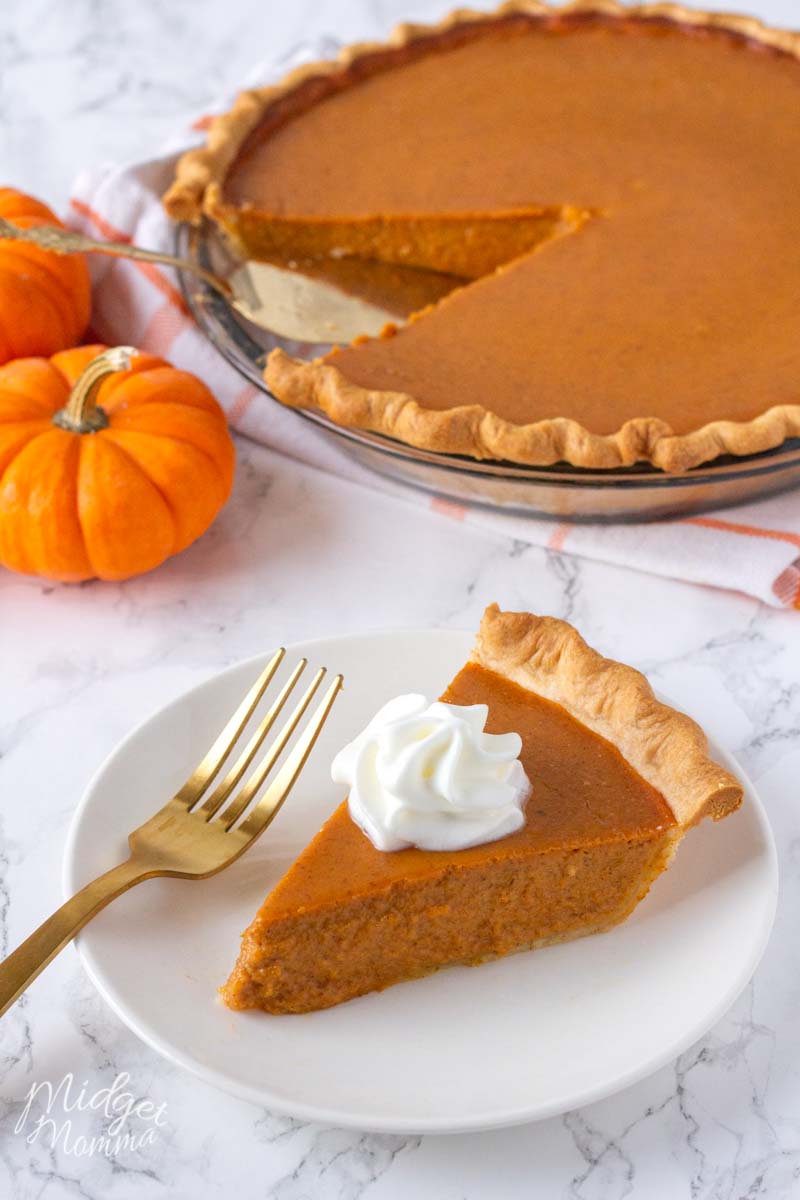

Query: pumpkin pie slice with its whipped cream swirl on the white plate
left=222, top=605, right=742, bottom=1013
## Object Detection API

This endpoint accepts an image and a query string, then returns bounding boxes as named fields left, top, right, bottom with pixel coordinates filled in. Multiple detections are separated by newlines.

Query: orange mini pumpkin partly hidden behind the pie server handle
left=0, top=187, right=91, bottom=362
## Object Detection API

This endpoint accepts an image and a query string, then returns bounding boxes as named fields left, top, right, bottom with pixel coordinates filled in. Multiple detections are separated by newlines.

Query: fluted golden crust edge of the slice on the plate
left=473, top=605, right=742, bottom=829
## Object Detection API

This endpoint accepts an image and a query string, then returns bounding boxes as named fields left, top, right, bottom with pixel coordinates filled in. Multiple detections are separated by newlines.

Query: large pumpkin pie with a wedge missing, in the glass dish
left=166, top=0, right=800, bottom=470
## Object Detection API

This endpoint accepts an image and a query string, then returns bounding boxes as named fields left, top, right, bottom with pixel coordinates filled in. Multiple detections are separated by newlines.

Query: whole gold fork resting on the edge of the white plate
left=0, top=649, right=342, bottom=1016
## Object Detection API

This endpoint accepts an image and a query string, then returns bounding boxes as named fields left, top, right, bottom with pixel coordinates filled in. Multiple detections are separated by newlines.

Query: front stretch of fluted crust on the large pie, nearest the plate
left=264, top=349, right=800, bottom=472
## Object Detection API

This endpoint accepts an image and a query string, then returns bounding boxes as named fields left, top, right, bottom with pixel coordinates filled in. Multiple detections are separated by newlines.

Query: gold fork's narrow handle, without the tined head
left=0, top=858, right=149, bottom=1016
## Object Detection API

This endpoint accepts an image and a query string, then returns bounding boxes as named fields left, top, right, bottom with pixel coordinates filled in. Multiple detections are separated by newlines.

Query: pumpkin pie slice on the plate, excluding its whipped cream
left=223, top=605, right=742, bottom=1013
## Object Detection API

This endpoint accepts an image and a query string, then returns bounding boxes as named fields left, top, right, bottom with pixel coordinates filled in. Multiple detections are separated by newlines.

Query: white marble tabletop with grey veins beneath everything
left=0, top=0, right=800, bottom=1200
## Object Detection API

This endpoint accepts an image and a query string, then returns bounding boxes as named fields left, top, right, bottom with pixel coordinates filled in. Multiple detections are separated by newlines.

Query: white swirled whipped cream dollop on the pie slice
left=331, top=695, right=530, bottom=851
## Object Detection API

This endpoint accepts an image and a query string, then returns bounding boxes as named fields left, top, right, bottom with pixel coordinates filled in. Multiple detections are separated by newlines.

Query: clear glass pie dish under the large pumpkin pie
left=175, top=222, right=800, bottom=522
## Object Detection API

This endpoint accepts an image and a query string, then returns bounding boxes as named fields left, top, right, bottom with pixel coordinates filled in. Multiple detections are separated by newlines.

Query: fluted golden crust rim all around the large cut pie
left=164, top=0, right=800, bottom=472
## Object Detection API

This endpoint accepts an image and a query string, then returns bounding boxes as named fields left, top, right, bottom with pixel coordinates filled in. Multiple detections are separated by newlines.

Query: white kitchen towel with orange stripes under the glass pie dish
left=70, top=43, right=800, bottom=608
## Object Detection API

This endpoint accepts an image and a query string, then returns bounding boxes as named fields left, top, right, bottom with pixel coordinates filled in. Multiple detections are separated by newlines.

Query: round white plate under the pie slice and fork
left=65, top=631, right=777, bottom=1133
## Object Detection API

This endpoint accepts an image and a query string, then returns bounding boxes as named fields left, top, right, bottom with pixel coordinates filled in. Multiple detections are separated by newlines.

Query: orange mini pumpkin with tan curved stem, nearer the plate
left=0, top=346, right=234, bottom=581
